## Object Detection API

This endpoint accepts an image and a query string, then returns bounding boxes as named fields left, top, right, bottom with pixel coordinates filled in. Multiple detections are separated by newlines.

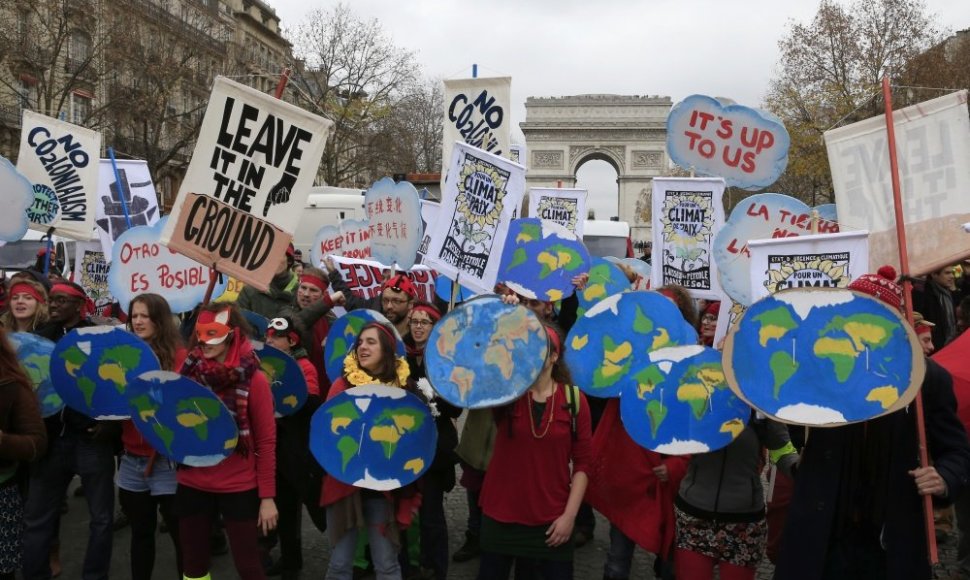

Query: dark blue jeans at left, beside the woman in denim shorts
left=23, top=434, right=115, bottom=580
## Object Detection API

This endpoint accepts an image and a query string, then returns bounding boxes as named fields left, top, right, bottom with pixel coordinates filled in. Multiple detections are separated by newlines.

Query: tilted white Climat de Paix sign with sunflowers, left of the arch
left=424, top=143, right=525, bottom=293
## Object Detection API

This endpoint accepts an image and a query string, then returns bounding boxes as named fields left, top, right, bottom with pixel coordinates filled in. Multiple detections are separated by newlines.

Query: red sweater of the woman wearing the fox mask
left=178, top=372, right=276, bottom=499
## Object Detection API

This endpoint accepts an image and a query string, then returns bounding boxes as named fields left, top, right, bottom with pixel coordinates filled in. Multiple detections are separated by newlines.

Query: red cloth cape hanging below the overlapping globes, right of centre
left=586, top=399, right=690, bottom=557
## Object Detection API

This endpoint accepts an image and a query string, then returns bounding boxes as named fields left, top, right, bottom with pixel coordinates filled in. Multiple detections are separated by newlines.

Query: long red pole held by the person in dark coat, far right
left=882, top=76, right=940, bottom=565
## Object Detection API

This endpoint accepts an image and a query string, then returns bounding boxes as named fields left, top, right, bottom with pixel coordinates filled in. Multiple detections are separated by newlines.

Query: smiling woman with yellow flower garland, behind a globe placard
left=321, top=322, right=417, bottom=580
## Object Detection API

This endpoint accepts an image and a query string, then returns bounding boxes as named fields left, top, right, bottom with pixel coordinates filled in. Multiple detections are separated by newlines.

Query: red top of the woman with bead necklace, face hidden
left=479, top=385, right=592, bottom=526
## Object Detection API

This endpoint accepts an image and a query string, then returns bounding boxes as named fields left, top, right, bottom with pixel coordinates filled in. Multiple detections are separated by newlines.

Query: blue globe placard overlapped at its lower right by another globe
left=566, top=291, right=697, bottom=397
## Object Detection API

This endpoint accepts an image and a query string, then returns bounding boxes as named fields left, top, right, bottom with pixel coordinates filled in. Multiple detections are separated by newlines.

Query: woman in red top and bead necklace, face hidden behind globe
left=478, top=326, right=592, bottom=580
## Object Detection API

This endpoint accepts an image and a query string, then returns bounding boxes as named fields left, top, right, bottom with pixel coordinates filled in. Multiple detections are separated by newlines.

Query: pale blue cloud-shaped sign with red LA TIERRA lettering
left=713, top=193, right=839, bottom=306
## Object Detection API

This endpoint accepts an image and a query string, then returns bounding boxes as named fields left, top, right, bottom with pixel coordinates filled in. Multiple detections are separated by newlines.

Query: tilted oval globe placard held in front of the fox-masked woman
left=128, top=371, right=239, bottom=467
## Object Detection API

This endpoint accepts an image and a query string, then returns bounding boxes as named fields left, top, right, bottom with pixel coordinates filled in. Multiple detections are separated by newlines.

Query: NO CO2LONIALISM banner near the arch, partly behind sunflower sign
left=441, top=77, right=510, bottom=184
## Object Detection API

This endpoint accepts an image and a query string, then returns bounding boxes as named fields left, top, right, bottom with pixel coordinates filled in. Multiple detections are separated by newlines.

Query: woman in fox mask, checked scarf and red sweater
left=175, top=304, right=278, bottom=580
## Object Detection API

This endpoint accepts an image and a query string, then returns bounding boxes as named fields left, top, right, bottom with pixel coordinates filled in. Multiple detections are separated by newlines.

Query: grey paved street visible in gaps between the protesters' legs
left=51, top=476, right=956, bottom=580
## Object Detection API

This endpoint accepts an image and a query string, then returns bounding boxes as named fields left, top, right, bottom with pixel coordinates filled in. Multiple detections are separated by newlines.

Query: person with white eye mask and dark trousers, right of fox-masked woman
left=266, top=316, right=327, bottom=580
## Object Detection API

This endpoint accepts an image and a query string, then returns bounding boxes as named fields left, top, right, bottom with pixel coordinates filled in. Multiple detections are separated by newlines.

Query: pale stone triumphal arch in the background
left=519, top=95, right=672, bottom=243
